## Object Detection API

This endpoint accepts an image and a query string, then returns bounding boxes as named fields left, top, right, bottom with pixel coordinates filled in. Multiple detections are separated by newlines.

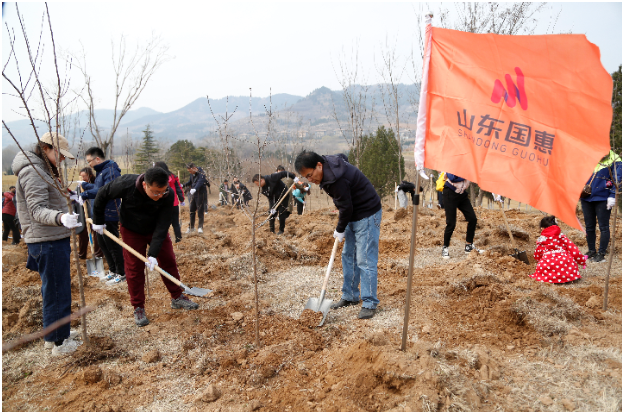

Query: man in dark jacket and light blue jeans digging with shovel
left=294, top=150, right=382, bottom=319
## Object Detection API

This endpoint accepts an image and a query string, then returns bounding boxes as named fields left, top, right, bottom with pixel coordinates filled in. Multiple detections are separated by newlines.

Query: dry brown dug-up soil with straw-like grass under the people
left=2, top=207, right=622, bottom=412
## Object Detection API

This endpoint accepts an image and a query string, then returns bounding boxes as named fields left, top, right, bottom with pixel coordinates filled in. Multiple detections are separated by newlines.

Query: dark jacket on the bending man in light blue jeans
left=320, top=153, right=382, bottom=233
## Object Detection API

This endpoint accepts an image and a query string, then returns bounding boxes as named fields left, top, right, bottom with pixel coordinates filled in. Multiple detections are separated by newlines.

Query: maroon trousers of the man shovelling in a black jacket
left=121, top=226, right=183, bottom=308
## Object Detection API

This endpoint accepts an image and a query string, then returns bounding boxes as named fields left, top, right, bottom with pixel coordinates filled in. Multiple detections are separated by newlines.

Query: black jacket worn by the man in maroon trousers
left=93, top=174, right=175, bottom=257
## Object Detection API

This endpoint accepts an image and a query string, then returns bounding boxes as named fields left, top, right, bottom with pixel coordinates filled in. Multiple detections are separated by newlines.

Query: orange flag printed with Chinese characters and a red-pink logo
left=415, top=27, right=613, bottom=230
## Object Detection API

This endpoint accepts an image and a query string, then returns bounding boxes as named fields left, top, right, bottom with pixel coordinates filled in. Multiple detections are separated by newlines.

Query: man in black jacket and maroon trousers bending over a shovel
left=93, top=167, right=199, bottom=326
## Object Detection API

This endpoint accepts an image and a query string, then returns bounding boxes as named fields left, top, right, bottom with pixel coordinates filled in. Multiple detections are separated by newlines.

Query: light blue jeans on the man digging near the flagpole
left=341, top=210, right=382, bottom=309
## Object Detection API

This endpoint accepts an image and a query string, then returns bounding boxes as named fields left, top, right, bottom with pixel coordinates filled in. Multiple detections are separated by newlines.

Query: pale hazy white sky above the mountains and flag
left=2, top=1, right=622, bottom=121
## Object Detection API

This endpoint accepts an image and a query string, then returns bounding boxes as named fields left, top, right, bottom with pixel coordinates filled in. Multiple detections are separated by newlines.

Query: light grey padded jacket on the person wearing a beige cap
left=11, top=152, right=71, bottom=243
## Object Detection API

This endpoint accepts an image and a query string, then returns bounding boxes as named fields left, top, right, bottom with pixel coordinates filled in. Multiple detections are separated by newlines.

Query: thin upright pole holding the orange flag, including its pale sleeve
left=401, top=12, right=433, bottom=351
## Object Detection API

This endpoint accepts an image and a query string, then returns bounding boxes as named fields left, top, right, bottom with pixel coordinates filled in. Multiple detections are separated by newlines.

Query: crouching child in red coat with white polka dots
left=529, top=216, right=587, bottom=283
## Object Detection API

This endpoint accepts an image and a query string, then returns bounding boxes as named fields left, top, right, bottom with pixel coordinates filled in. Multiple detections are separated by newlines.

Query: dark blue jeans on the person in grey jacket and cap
left=26, top=238, right=71, bottom=342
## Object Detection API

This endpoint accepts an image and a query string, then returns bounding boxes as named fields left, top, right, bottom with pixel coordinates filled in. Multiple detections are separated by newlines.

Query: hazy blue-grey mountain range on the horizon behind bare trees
left=2, top=84, right=418, bottom=148
